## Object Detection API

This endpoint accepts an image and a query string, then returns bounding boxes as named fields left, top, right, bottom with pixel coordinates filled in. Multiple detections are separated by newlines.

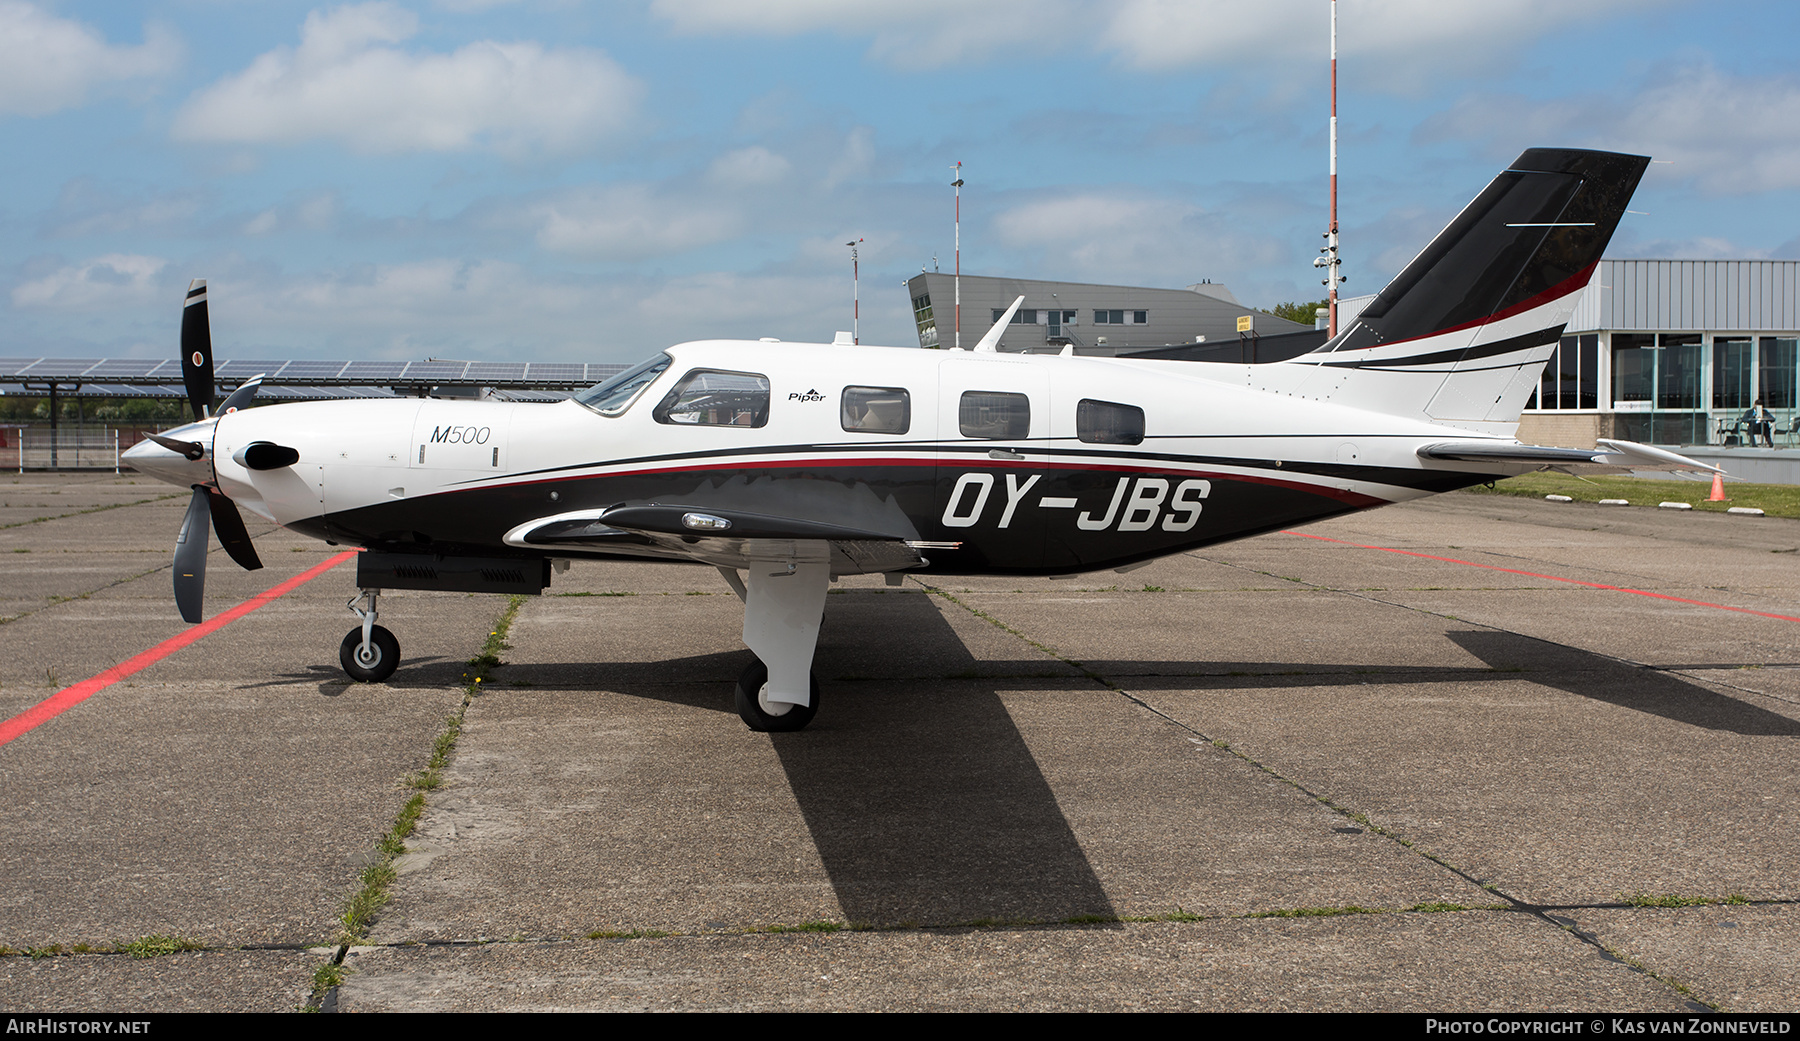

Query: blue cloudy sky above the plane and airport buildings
left=0, top=0, right=1800, bottom=362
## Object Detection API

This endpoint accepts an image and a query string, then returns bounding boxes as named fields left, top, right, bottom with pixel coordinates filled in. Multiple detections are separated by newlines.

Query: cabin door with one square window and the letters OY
left=932, top=355, right=1051, bottom=569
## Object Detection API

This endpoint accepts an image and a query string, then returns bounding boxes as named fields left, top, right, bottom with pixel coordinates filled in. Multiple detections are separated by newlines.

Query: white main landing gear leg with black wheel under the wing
left=720, top=557, right=832, bottom=731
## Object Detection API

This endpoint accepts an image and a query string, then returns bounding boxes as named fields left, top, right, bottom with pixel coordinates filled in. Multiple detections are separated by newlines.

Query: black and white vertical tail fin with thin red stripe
left=1267, top=148, right=1651, bottom=432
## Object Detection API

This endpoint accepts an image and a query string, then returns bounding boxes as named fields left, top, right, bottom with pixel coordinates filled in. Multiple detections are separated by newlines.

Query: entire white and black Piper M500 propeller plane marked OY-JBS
left=126, top=148, right=1712, bottom=731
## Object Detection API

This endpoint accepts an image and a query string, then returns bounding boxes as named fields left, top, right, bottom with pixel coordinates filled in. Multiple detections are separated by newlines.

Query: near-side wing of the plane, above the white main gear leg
left=506, top=502, right=938, bottom=575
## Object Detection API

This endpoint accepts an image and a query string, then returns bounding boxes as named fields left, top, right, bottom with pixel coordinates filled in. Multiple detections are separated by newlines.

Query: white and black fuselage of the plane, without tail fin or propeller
left=189, top=340, right=1510, bottom=573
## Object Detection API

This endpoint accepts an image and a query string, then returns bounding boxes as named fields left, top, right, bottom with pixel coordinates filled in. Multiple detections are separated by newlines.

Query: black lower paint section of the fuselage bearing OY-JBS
left=288, top=443, right=1490, bottom=575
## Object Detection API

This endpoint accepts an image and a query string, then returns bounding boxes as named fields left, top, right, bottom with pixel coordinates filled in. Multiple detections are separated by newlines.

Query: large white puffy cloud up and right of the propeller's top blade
left=173, top=4, right=643, bottom=155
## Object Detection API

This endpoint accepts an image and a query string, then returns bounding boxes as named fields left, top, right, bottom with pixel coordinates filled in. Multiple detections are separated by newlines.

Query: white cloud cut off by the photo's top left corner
left=0, top=0, right=182, bottom=115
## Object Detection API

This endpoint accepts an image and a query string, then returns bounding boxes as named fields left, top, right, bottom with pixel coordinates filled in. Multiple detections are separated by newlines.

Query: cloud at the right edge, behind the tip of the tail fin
left=1418, top=65, right=1800, bottom=195
